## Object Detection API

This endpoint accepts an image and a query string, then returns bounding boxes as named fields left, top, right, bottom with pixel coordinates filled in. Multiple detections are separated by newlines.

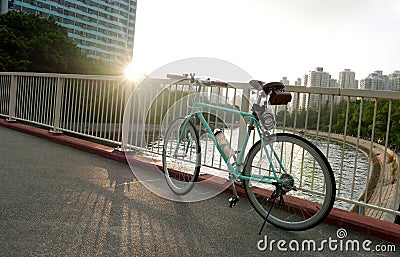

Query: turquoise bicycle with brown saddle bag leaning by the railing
left=162, top=74, right=336, bottom=230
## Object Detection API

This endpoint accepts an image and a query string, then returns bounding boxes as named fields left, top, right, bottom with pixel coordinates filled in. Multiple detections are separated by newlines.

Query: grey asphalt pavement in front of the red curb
left=0, top=127, right=400, bottom=256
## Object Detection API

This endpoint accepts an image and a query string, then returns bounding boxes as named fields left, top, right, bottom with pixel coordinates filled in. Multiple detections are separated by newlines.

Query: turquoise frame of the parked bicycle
left=178, top=90, right=286, bottom=184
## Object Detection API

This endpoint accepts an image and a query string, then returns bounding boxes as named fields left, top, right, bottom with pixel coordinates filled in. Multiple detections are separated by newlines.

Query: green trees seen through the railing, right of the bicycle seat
left=276, top=100, right=400, bottom=145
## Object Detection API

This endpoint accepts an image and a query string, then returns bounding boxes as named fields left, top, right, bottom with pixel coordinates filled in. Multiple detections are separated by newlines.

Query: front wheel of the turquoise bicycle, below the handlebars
left=162, top=118, right=201, bottom=195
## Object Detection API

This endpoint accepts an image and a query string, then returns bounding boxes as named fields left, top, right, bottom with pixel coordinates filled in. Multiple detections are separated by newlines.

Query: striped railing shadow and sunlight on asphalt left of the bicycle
left=43, top=162, right=239, bottom=256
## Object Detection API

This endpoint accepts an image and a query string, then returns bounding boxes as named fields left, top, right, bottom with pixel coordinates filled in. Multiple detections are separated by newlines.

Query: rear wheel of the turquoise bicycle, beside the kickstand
left=243, top=133, right=336, bottom=230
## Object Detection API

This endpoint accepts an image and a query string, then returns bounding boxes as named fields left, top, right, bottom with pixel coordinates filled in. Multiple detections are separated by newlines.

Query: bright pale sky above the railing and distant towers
left=133, top=0, right=400, bottom=84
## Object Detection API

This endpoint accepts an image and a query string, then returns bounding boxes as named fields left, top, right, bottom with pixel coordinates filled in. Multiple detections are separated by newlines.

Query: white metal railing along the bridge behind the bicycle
left=0, top=73, right=400, bottom=221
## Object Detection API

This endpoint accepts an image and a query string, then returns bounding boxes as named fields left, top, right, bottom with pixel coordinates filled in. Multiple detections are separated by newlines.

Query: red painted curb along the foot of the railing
left=0, top=119, right=400, bottom=245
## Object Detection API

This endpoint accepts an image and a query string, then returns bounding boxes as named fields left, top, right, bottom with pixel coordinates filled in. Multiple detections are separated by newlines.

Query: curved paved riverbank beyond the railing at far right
left=292, top=130, right=400, bottom=222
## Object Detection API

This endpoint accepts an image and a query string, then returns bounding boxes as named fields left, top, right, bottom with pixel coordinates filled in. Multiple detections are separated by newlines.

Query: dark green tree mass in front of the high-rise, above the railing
left=0, top=11, right=121, bottom=75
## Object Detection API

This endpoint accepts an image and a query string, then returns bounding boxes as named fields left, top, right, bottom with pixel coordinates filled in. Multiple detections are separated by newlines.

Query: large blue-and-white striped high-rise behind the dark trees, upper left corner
left=0, top=0, right=136, bottom=63
